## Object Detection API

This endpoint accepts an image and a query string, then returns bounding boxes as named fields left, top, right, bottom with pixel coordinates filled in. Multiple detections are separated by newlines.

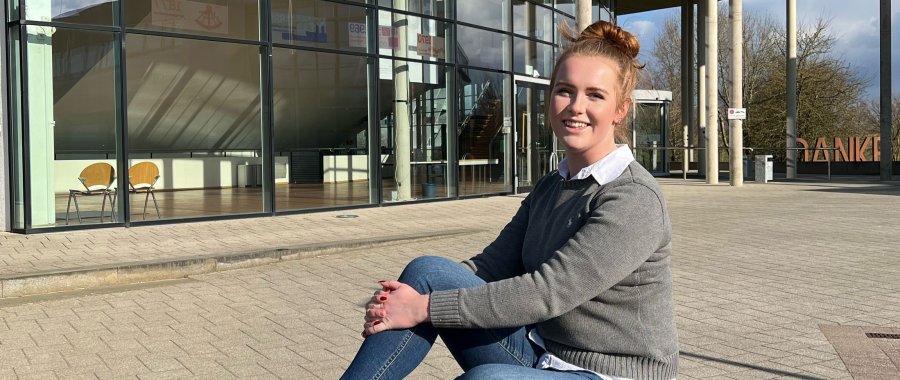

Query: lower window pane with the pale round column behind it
left=378, top=59, right=448, bottom=202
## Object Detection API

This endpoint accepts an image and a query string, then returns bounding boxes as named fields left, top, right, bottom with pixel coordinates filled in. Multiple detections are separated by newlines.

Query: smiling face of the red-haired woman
left=550, top=55, right=630, bottom=164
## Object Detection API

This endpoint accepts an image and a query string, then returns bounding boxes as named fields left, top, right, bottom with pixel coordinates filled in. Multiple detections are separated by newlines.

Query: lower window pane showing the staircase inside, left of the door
left=457, top=69, right=512, bottom=195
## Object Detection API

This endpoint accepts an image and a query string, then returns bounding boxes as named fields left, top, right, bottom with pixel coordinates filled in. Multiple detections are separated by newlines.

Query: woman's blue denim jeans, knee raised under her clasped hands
left=341, top=256, right=596, bottom=379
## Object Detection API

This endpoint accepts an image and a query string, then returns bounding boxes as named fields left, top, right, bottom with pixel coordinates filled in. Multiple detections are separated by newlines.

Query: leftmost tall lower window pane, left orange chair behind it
left=25, top=26, right=116, bottom=228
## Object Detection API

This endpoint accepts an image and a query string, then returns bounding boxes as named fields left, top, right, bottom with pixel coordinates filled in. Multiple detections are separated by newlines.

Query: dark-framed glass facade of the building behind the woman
left=5, top=0, right=609, bottom=232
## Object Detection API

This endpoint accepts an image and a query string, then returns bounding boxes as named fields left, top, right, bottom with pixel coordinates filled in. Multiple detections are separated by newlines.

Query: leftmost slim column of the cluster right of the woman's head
left=681, top=0, right=694, bottom=175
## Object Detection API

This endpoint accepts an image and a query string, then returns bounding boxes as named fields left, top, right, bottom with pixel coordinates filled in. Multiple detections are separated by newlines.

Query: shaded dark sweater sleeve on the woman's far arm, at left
left=462, top=195, right=531, bottom=282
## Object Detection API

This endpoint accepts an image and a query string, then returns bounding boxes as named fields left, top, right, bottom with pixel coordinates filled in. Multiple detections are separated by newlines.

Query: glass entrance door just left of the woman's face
left=515, top=81, right=559, bottom=192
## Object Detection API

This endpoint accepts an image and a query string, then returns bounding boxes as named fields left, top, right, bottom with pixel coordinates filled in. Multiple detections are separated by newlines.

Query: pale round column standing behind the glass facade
left=393, top=1, right=412, bottom=201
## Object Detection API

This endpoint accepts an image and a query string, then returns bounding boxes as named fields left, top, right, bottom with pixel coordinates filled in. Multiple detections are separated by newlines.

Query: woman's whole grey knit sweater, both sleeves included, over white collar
left=429, top=162, right=678, bottom=379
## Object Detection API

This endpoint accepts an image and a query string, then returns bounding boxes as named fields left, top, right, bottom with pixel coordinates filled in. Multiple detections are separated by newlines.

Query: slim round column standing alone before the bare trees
left=785, top=0, right=797, bottom=178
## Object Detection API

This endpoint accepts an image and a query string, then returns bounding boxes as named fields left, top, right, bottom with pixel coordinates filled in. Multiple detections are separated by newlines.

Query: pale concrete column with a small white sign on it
left=728, top=0, right=744, bottom=186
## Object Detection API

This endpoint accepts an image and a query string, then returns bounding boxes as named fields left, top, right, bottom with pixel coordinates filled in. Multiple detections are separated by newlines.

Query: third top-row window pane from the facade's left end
left=272, top=0, right=368, bottom=52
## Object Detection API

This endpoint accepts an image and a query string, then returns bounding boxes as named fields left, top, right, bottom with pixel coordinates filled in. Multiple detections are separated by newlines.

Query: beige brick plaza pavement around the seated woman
left=0, top=177, right=900, bottom=380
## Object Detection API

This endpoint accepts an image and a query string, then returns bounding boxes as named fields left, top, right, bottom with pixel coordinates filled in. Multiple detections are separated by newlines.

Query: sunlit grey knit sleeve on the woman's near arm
left=429, top=182, right=668, bottom=328
